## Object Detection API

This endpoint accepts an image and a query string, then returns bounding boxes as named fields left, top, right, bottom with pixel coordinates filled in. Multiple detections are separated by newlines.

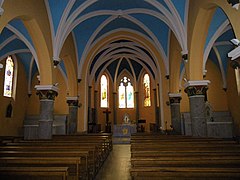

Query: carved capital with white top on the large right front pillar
left=184, top=80, right=210, bottom=97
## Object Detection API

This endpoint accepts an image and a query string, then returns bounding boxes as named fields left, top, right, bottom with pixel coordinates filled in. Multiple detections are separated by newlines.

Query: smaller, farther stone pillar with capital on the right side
left=168, top=93, right=182, bottom=134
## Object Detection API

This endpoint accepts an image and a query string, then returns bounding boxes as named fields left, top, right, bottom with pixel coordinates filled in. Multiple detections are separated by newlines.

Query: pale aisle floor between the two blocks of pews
left=95, top=144, right=131, bottom=180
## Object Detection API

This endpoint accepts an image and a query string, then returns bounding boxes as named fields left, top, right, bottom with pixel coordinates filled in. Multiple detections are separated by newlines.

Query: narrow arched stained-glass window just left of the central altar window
left=101, top=75, right=108, bottom=108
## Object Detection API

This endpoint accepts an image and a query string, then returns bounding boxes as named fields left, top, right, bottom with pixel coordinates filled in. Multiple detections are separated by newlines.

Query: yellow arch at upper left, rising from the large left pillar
left=0, top=1, right=53, bottom=84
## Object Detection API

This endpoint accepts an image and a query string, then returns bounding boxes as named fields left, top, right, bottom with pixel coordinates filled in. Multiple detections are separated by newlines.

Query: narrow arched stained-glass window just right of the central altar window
left=143, top=74, right=151, bottom=107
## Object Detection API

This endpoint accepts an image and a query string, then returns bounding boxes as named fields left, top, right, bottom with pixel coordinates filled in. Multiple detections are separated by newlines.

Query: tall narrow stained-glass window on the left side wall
left=3, top=56, right=14, bottom=97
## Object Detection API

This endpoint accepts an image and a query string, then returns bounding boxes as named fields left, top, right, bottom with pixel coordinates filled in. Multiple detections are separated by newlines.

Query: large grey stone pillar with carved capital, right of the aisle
left=185, top=80, right=210, bottom=137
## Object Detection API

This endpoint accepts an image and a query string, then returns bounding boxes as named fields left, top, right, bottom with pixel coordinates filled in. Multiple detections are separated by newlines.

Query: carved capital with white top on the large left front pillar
left=35, top=85, right=58, bottom=100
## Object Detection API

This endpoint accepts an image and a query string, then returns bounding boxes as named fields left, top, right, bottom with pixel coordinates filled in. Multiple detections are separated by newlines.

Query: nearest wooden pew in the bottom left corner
left=0, top=167, right=68, bottom=180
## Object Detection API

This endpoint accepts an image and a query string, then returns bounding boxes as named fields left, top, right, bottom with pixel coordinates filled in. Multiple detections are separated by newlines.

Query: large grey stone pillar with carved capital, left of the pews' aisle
left=35, top=85, right=58, bottom=139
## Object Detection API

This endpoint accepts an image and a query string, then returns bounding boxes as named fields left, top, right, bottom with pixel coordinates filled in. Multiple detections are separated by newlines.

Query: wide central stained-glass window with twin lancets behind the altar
left=118, top=77, right=134, bottom=108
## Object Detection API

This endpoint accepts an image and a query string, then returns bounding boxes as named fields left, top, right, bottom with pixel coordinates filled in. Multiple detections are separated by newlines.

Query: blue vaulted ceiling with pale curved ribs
left=0, top=0, right=234, bottom=91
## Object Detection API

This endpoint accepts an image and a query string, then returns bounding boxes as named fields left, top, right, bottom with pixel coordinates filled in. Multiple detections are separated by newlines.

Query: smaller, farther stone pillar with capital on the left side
left=66, top=97, right=78, bottom=134
